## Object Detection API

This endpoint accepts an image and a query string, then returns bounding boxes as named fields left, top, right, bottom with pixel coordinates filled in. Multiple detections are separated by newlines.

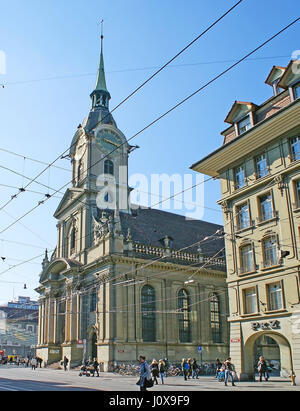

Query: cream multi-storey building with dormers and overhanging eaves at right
left=192, top=61, right=300, bottom=379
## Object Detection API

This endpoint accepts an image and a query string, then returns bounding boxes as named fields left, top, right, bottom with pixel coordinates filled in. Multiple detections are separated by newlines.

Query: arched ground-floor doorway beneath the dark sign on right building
left=242, top=331, right=293, bottom=379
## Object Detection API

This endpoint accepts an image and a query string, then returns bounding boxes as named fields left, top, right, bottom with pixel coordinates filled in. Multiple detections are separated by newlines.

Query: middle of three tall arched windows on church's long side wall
left=178, top=290, right=192, bottom=343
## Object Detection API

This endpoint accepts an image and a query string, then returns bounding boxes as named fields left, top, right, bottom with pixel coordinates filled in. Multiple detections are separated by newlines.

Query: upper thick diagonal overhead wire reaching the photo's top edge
left=0, top=0, right=243, bottom=216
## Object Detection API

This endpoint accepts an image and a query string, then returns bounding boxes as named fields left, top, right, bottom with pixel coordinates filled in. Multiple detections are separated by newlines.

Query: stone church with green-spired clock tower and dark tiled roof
left=37, top=38, right=228, bottom=371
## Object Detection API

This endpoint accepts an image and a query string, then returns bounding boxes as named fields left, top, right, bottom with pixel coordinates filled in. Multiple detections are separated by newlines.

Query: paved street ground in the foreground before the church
left=0, top=367, right=300, bottom=392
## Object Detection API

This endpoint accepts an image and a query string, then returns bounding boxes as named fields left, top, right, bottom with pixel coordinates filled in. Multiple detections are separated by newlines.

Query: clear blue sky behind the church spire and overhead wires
left=0, top=0, right=300, bottom=304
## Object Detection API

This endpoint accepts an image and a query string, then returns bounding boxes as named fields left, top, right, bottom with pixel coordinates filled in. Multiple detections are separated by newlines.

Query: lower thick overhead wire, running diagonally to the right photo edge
left=0, top=17, right=300, bottom=234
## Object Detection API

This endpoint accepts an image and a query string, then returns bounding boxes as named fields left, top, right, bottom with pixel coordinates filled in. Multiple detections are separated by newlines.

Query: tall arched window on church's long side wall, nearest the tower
left=141, top=285, right=156, bottom=342
